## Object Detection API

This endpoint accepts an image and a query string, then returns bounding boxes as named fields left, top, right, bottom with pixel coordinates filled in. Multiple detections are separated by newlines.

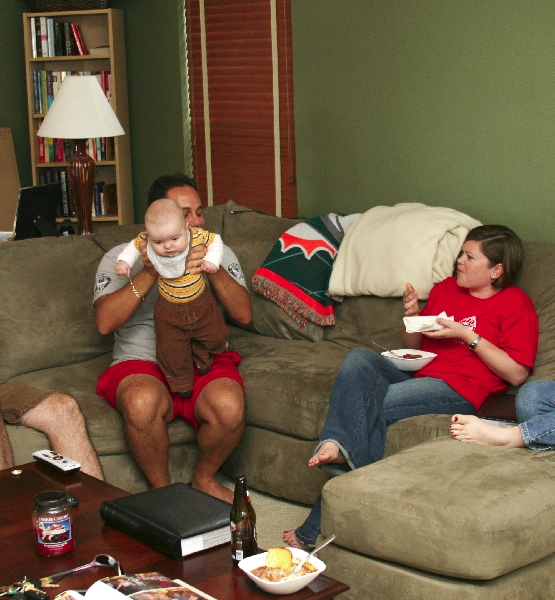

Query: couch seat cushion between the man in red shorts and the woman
left=229, top=327, right=346, bottom=440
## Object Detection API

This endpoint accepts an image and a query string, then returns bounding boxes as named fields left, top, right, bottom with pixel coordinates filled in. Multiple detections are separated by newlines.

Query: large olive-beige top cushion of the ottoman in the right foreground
left=322, top=437, right=555, bottom=580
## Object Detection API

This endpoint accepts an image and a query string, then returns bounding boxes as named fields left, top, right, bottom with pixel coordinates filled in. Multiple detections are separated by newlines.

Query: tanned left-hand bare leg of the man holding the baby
left=116, top=374, right=173, bottom=488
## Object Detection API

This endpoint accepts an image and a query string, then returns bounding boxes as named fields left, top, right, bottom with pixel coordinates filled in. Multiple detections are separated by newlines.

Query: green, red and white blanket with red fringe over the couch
left=252, top=213, right=360, bottom=328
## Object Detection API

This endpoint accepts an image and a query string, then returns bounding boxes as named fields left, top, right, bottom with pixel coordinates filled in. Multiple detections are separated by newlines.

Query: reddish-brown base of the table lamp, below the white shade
left=67, top=140, right=96, bottom=235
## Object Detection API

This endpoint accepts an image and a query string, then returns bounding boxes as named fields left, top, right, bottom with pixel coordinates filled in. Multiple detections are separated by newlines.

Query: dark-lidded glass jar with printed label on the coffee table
left=33, top=491, right=74, bottom=556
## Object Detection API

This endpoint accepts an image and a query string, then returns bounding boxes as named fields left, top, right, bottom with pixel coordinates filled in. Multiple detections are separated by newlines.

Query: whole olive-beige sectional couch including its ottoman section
left=0, top=203, right=555, bottom=599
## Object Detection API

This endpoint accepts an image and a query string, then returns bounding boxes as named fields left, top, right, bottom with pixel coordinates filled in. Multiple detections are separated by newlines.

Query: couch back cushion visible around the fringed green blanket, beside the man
left=223, top=200, right=324, bottom=342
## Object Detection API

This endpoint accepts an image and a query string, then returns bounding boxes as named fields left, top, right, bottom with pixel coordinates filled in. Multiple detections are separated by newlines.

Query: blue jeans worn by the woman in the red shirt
left=295, top=348, right=476, bottom=546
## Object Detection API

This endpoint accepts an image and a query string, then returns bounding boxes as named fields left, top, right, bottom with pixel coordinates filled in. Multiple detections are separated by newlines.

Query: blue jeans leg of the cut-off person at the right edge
left=516, top=381, right=555, bottom=450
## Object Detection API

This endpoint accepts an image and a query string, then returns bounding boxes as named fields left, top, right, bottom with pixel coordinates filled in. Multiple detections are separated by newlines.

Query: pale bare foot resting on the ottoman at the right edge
left=449, top=415, right=524, bottom=448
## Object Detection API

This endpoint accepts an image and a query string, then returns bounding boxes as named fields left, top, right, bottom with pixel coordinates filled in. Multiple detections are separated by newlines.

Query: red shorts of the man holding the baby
left=96, top=350, right=244, bottom=431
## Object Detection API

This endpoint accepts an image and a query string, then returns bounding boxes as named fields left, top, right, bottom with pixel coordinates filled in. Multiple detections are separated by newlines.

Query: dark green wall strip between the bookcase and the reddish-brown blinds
left=111, top=0, right=191, bottom=223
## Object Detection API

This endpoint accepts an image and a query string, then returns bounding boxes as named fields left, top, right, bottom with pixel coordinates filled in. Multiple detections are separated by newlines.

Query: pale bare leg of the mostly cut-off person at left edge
left=19, top=393, right=104, bottom=480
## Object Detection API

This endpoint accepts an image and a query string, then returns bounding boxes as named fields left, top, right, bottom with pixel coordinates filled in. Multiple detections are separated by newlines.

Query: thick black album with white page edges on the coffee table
left=100, top=483, right=231, bottom=560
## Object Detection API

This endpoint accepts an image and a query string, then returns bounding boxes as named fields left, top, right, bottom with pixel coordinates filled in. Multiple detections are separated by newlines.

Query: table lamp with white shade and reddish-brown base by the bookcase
left=37, top=75, right=125, bottom=235
